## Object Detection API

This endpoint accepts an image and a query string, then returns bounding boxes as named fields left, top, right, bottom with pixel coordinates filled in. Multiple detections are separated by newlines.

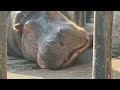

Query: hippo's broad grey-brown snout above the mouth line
left=39, top=28, right=89, bottom=69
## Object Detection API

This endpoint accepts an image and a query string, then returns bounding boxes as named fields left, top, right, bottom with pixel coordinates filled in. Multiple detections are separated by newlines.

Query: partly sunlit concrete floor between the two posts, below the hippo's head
left=8, top=56, right=91, bottom=79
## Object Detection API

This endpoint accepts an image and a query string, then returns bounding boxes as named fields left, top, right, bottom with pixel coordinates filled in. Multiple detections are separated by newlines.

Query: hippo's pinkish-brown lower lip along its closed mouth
left=60, top=40, right=90, bottom=68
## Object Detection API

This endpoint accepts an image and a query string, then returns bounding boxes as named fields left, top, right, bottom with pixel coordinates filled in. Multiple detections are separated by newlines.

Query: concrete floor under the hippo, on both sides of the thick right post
left=7, top=49, right=120, bottom=79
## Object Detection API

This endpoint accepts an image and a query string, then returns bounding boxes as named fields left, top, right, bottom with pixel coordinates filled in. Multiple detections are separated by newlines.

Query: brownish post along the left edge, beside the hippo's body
left=0, top=11, right=7, bottom=79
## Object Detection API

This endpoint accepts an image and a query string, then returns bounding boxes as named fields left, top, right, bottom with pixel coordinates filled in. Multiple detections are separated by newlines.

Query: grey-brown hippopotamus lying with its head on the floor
left=7, top=11, right=91, bottom=70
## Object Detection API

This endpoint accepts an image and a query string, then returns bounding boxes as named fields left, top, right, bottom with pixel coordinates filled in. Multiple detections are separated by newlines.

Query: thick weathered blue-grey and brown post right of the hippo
left=92, top=11, right=113, bottom=79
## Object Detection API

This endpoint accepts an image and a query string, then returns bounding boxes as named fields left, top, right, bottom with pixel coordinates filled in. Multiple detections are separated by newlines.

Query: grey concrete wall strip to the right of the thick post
left=112, top=11, right=120, bottom=56
